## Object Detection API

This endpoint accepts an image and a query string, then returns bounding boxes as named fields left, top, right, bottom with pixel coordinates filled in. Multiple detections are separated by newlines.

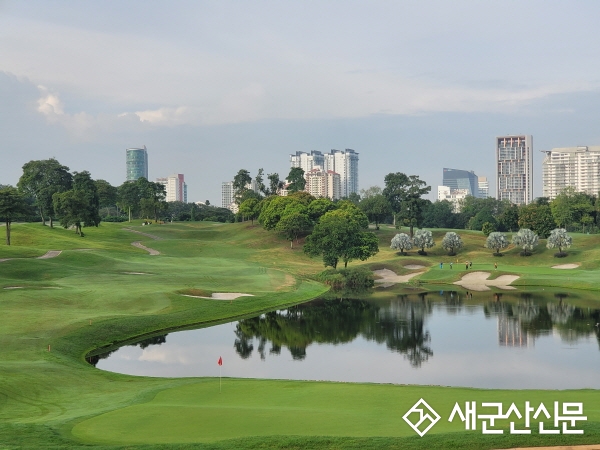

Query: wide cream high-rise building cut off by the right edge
left=542, top=145, right=600, bottom=199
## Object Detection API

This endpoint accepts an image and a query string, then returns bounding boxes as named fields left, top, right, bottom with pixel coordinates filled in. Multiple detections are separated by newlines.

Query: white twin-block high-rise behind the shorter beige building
left=290, top=148, right=358, bottom=197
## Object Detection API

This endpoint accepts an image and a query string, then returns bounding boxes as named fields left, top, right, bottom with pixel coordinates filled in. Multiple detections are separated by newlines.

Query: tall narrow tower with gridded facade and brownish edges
left=496, top=135, right=533, bottom=205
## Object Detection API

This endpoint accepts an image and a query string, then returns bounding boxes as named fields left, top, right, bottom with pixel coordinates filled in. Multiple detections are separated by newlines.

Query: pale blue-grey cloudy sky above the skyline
left=0, top=0, right=600, bottom=205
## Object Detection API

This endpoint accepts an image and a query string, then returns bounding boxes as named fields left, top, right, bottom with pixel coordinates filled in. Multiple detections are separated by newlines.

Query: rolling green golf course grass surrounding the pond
left=0, top=220, right=600, bottom=449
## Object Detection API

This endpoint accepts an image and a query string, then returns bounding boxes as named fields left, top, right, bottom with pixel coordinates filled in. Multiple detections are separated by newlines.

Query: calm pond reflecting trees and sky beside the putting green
left=88, top=291, right=600, bottom=389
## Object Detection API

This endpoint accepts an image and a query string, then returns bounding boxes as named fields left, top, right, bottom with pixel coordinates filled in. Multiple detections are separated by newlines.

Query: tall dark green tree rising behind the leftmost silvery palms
left=383, top=172, right=431, bottom=236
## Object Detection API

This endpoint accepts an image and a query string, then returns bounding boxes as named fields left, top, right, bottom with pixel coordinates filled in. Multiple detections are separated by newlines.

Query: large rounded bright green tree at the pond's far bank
left=304, top=207, right=379, bottom=269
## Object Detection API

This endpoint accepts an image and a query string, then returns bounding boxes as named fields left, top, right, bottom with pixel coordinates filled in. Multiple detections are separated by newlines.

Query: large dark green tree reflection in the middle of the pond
left=234, top=296, right=433, bottom=367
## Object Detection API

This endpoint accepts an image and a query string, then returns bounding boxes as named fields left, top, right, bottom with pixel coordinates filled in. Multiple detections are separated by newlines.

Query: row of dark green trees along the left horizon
left=0, top=158, right=233, bottom=245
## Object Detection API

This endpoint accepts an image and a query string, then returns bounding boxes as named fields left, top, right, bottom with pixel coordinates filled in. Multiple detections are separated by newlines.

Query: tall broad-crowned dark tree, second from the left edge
left=17, top=158, right=73, bottom=227
